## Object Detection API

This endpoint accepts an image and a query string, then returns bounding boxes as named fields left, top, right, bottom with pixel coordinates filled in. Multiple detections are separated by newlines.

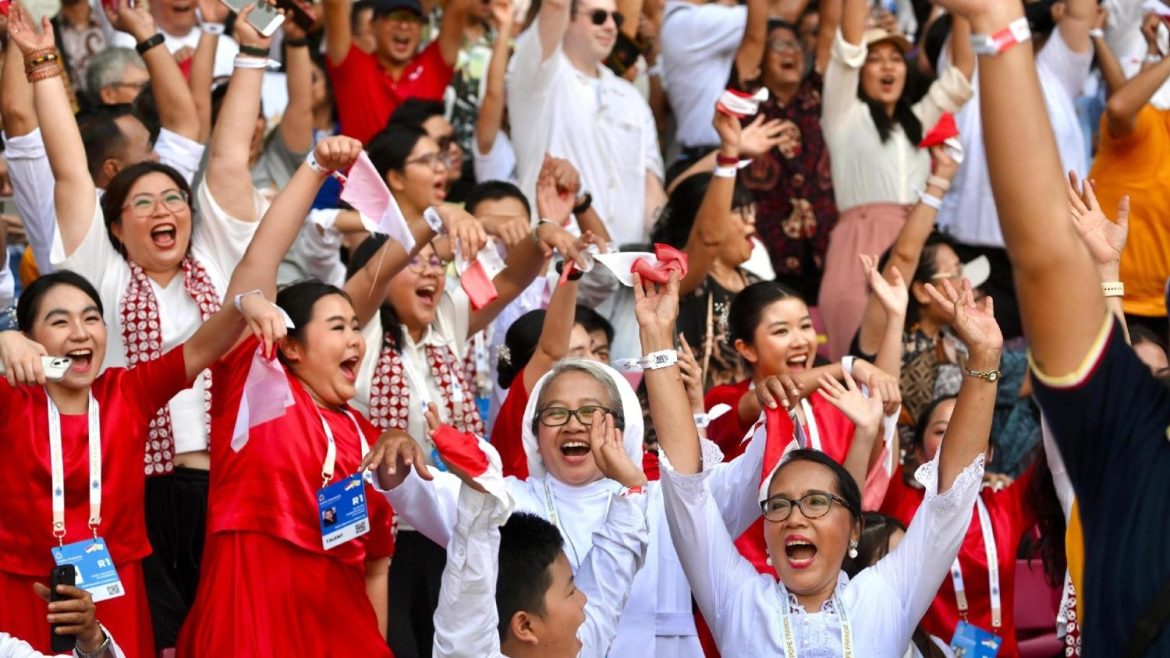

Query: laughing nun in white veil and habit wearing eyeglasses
left=367, top=277, right=764, bottom=658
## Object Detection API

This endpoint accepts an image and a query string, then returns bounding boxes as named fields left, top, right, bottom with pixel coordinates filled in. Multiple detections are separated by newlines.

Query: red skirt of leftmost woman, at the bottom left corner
left=0, top=554, right=154, bottom=658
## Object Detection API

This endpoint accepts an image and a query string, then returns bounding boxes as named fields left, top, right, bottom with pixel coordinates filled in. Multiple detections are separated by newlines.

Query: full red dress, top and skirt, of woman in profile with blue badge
left=178, top=338, right=393, bottom=658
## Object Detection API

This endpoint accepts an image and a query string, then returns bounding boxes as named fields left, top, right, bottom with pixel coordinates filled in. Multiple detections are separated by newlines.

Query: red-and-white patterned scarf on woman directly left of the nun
left=370, top=336, right=483, bottom=437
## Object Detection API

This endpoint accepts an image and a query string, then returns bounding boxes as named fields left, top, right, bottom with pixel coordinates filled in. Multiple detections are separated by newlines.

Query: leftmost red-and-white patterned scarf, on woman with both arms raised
left=118, top=255, right=220, bottom=475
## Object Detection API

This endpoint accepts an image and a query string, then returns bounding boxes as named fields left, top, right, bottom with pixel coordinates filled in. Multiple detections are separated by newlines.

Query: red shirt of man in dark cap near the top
left=329, top=41, right=455, bottom=143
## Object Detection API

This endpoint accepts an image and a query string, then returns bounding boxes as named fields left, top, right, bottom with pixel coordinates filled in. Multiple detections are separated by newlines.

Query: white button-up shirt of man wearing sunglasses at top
left=508, top=25, right=662, bottom=245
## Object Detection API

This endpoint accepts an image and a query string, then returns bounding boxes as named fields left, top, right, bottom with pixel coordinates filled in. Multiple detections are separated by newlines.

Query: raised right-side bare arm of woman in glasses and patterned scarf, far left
left=206, top=5, right=270, bottom=221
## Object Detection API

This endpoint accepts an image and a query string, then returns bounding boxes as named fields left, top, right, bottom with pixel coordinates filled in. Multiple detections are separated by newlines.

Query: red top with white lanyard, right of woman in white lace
left=881, top=468, right=1035, bottom=658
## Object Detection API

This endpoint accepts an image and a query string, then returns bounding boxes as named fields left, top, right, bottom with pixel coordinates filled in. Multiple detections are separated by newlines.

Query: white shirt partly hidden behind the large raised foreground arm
left=938, top=28, right=1093, bottom=248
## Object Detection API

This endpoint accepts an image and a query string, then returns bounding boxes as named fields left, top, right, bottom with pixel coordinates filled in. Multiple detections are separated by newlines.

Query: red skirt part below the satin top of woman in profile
left=175, top=529, right=392, bottom=658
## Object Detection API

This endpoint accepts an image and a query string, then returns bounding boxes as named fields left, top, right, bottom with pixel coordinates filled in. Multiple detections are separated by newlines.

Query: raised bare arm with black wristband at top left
left=102, top=0, right=199, bottom=140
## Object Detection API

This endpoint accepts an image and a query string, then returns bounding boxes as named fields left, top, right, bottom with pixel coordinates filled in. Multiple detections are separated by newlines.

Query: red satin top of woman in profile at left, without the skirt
left=207, top=338, right=393, bottom=566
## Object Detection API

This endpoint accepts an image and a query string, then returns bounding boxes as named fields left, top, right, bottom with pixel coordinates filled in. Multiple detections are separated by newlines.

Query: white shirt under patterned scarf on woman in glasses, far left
left=51, top=181, right=267, bottom=454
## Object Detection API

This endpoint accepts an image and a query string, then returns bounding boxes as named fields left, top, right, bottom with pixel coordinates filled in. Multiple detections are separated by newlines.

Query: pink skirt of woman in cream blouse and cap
left=818, top=204, right=909, bottom=359
